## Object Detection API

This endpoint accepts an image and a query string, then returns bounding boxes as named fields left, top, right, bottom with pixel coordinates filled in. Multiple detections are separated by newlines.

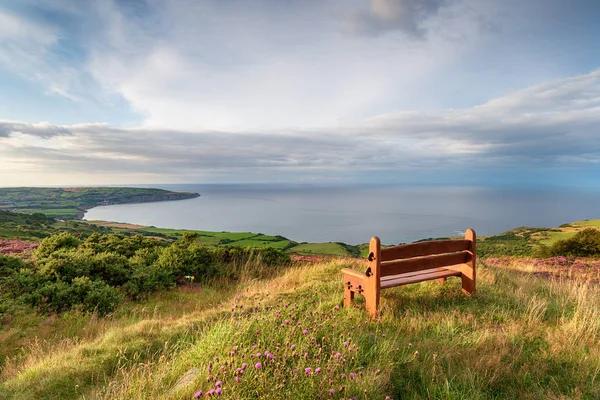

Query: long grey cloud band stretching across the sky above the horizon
left=0, top=70, right=600, bottom=186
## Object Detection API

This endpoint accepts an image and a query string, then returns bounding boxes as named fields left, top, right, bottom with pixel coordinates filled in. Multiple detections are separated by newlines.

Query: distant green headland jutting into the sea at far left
left=0, top=187, right=199, bottom=219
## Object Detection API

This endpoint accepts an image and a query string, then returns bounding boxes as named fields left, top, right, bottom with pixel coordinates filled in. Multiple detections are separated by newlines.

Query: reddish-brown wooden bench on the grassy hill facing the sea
left=342, top=229, right=476, bottom=317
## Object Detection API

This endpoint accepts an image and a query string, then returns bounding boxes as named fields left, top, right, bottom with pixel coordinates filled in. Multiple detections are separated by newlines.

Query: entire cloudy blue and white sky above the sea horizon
left=0, top=0, right=600, bottom=188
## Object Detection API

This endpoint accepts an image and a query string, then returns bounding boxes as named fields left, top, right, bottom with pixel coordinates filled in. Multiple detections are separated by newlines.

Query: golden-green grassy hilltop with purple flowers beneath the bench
left=0, top=260, right=600, bottom=399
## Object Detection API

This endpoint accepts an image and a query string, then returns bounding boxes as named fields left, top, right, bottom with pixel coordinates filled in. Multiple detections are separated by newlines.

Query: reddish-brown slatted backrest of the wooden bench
left=369, top=229, right=475, bottom=277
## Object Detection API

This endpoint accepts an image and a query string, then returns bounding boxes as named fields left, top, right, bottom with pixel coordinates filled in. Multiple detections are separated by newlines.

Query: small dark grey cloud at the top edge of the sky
left=343, top=0, right=447, bottom=37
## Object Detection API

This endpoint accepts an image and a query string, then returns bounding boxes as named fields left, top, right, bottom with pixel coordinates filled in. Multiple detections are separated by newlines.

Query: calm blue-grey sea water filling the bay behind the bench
left=85, top=185, right=600, bottom=244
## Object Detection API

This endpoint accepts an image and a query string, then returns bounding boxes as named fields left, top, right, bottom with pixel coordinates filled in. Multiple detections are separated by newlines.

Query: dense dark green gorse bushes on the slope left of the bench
left=0, top=233, right=289, bottom=319
